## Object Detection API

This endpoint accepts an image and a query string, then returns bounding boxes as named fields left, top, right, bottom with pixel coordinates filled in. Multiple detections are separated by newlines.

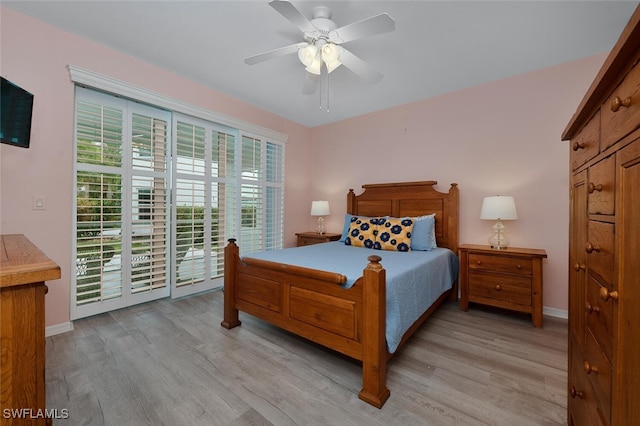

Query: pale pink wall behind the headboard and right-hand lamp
left=309, top=54, right=606, bottom=314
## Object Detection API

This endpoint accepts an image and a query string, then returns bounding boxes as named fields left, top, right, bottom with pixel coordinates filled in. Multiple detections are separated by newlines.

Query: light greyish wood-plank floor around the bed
left=46, top=291, right=567, bottom=426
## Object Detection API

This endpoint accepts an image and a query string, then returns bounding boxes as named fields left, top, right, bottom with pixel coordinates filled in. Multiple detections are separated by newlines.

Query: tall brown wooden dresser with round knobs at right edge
left=562, top=8, right=640, bottom=426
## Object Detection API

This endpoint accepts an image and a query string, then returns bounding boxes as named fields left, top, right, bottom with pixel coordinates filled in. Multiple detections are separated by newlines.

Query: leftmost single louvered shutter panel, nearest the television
left=75, top=100, right=124, bottom=306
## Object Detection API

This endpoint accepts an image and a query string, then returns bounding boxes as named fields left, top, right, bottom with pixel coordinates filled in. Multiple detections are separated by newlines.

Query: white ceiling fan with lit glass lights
left=244, top=0, right=396, bottom=94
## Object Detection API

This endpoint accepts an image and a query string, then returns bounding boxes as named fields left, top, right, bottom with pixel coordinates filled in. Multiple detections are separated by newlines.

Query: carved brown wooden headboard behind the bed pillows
left=347, top=180, right=458, bottom=255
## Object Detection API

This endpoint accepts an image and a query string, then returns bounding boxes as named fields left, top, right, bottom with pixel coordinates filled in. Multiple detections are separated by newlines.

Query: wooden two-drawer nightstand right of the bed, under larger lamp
left=458, top=244, right=547, bottom=327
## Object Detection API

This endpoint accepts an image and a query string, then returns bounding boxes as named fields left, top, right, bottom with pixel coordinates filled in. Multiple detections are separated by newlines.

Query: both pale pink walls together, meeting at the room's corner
left=0, top=7, right=604, bottom=326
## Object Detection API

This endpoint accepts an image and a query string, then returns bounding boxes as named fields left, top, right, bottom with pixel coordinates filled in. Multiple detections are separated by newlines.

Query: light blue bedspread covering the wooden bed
left=242, top=241, right=458, bottom=353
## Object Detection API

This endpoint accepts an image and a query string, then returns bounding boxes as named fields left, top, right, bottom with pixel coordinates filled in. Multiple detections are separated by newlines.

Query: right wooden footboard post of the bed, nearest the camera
left=358, top=255, right=391, bottom=408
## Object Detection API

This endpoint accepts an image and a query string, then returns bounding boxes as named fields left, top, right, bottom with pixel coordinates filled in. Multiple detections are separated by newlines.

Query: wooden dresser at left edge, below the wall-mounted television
left=0, top=235, right=60, bottom=425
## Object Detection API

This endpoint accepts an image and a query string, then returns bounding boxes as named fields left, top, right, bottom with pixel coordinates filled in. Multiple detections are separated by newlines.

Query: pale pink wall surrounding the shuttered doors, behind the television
left=0, top=7, right=311, bottom=326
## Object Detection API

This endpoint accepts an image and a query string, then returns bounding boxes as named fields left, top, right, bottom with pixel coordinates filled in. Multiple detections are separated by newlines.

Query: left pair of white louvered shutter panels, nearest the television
left=71, top=88, right=169, bottom=319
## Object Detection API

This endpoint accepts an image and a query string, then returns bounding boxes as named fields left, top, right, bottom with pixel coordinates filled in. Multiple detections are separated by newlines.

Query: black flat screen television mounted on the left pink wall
left=0, top=77, right=33, bottom=148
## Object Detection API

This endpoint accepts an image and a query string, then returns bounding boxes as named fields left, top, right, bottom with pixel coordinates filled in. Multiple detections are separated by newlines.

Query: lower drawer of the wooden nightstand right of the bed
left=469, top=272, right=531, bottom=308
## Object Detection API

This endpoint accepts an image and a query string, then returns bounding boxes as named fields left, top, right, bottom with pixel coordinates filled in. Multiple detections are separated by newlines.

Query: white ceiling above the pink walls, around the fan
left=2, top=0, right=638, bottom=127
